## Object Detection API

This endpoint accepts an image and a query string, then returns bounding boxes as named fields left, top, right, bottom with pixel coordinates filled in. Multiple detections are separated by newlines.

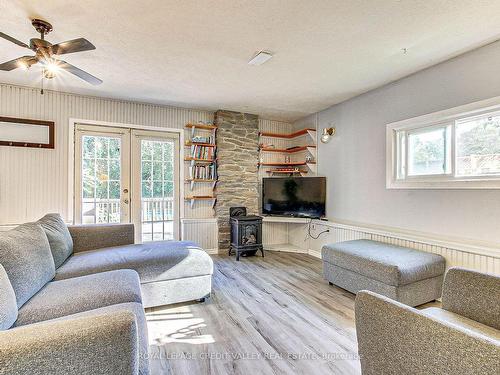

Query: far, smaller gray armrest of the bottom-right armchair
left=442, top=267, right=500, bottom=330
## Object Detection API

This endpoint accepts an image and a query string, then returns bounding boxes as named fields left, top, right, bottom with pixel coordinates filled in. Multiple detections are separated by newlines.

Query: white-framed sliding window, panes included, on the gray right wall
left=387, top=98, right=500, bottom=189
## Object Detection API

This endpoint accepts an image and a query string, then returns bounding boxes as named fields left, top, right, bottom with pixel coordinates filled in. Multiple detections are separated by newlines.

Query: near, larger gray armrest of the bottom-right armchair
left=355, top=291, right=500, bottom=375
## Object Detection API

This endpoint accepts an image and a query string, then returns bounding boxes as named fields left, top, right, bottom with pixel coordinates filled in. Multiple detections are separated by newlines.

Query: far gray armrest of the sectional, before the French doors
left=68, top=224, right=135, bottom=253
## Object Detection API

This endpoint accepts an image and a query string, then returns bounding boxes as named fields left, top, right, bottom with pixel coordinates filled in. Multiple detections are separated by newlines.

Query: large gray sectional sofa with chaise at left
left=0, top=214, right=213, bottom=375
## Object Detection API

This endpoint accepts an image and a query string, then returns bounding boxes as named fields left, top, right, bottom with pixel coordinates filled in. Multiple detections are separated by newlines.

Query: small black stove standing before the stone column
left=229, top=207, right=264, bottom=260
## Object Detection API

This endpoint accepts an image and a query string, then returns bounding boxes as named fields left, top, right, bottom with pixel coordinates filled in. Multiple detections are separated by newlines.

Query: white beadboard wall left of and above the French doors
left=0, top=84, right=213, bottom=225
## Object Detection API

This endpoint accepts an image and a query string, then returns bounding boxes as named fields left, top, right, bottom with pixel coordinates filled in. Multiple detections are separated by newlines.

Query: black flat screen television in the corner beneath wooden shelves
left=262, top=177, right=326, bottom=218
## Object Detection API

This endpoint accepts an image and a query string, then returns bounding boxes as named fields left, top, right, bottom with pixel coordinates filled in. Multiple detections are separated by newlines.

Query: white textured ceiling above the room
left=0, top=0, right=500, bottom=120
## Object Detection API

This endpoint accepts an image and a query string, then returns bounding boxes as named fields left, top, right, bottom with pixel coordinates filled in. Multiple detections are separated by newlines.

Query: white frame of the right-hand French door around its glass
left=130, top=129, right=184, bottom=242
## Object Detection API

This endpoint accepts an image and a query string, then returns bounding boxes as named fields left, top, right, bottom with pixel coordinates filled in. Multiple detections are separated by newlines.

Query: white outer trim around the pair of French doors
left=67, top=118, right=184, bottom=228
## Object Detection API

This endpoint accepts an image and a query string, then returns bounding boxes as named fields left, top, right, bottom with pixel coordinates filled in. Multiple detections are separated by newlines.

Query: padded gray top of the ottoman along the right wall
left=321, top=240, right=445, bottom=286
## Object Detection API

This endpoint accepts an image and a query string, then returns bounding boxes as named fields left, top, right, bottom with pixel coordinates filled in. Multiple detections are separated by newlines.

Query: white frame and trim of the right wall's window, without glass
left=386, top=97, right=500, bottom=189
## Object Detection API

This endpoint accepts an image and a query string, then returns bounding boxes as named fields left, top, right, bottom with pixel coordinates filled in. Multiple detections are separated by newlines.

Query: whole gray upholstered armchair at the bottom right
left=355, top=268, right=500, bottom=375
